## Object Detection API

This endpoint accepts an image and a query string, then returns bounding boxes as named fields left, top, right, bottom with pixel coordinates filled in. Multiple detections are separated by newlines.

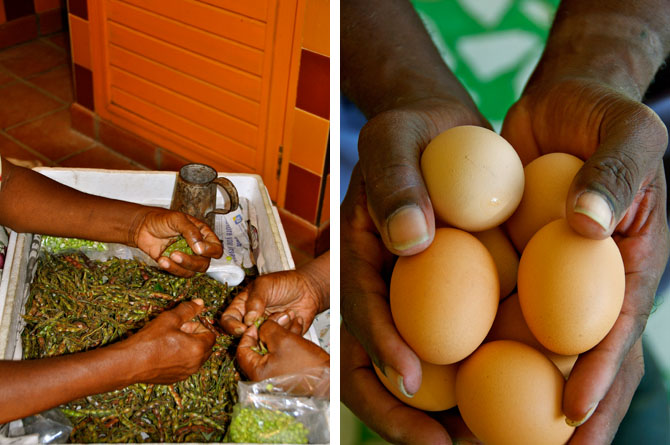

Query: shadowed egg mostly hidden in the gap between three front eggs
left=484, top=293, right=579, bottom=379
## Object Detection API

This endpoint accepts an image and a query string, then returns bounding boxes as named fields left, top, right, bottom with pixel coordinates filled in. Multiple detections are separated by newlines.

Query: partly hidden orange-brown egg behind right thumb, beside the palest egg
left=505, top=153, right=584, bottom=252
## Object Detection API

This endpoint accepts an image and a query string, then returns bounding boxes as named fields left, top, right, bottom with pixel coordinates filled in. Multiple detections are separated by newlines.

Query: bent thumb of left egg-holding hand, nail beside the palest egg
left=358, top=99, right=490, bottom=255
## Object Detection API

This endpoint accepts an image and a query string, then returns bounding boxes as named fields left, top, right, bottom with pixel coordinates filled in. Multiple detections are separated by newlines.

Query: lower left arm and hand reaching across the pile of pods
left=0, top=300, right=215, bottom=423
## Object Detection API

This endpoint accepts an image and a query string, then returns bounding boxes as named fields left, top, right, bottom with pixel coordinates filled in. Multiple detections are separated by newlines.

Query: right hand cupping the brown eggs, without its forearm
left=502, top=78, right=670, bottom=443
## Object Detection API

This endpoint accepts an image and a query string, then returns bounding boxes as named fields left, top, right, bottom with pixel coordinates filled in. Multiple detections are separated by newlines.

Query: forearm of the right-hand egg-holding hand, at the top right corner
left=529, top=0, right=670, bottom=100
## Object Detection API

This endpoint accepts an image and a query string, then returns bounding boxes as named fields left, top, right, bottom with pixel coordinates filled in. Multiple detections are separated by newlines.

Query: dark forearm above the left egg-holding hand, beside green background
left=340, top=0, right=476, bottom=118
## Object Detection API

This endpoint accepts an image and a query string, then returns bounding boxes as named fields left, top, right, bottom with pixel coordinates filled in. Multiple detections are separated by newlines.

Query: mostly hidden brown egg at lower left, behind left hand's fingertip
left=374, top=360, right=458, bottom=411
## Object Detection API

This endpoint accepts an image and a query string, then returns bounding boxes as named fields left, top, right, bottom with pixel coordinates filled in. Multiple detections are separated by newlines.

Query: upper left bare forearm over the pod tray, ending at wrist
left=0, top=159, right=150, bottom=245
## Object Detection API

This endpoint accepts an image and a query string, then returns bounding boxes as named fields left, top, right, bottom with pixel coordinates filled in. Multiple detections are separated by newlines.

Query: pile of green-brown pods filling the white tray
left=22, top=253, right=239, bottom=443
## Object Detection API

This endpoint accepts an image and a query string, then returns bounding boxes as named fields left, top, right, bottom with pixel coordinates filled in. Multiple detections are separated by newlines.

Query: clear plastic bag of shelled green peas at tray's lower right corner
left=227, top=368, right=330, bottom=443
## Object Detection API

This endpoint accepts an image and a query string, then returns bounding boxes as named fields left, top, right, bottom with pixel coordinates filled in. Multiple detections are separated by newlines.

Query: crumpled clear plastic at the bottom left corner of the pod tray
left=9, top=408, right=72, bottom=443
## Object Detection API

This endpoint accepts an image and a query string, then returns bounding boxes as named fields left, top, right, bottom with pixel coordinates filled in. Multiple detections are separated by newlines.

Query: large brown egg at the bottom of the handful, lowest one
left=456, top=340, right=574, bottom=445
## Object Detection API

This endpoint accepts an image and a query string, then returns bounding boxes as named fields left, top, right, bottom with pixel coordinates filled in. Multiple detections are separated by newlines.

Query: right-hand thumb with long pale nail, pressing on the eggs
left=566, top=106, right=667, bottom=239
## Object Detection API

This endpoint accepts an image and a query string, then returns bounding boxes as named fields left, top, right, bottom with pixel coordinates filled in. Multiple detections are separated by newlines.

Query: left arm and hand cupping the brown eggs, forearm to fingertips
left=340, top=0, right=490, bottom=443
